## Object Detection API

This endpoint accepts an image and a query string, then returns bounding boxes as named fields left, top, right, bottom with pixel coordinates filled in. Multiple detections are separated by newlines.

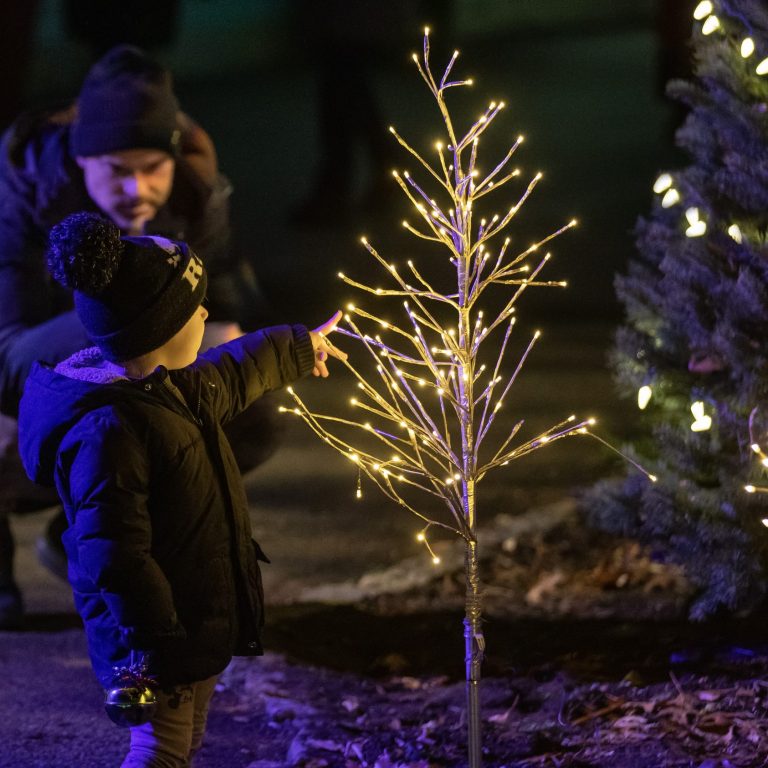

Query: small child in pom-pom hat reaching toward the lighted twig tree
left=19, top=213, right=346, bottom=768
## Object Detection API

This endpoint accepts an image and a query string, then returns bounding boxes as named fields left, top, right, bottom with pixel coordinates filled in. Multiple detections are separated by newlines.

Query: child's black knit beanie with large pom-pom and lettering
left=47, top=213, right=208, bottom=362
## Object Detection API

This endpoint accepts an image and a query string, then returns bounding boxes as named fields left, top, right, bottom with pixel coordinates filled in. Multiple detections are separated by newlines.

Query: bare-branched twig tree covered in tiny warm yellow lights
left=285, top=30, right=652, bottom=768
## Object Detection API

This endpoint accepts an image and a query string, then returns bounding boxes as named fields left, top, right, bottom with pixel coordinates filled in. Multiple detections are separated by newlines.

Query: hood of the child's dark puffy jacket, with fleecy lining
left=19, top=347, right=128, bottom=486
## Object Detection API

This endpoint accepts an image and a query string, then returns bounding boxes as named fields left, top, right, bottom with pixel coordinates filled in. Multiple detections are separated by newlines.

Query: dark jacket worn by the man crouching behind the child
left=0, top=107, right=246, bottom=415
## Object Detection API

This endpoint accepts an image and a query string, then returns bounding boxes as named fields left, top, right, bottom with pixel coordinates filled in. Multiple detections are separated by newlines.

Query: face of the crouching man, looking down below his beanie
left=77, top=149, right=176, bottom=235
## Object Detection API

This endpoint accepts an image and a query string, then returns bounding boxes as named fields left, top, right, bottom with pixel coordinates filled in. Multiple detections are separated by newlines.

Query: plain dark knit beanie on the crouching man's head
left=69, top=45, right=181, bottom=157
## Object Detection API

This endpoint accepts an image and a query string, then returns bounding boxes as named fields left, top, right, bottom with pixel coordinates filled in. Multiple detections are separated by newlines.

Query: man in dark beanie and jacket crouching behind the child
left=0, top=46, right=270, bottom=628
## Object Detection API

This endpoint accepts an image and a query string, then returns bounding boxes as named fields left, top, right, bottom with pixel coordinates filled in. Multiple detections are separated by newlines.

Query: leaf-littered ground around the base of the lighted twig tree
left=194, top=504, right=768, bottom=768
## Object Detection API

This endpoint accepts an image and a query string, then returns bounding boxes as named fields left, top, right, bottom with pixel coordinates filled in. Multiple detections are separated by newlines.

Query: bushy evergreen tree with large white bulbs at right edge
left=588, top=0, right=768, bottom=618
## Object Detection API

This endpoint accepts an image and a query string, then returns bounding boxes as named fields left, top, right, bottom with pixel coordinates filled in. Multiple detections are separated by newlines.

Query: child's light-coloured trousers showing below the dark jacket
left=121, top=675, right=218, bottom=768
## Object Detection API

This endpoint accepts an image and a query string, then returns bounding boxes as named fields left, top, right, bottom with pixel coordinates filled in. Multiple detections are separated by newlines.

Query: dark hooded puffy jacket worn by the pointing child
left=19, top=326, right=314, bottom=685
